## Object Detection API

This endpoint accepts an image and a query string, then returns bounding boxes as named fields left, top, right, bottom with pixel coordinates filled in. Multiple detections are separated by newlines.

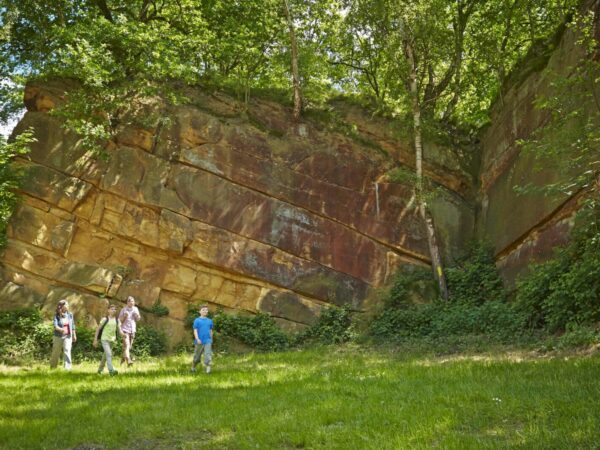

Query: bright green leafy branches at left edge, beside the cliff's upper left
left=0, top=131, right=35, bottom=248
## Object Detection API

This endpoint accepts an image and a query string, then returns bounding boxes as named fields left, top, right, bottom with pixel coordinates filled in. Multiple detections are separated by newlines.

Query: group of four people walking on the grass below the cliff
left=50, top=296, right=213, bottom=375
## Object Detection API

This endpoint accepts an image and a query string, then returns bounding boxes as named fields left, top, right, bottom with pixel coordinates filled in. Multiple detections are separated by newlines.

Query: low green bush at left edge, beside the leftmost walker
left=0, top=308, right=52, bottom=364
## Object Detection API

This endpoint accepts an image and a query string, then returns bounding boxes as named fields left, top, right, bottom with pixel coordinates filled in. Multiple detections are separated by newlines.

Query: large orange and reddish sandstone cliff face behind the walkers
left=0, top=82, right=474, bottom=344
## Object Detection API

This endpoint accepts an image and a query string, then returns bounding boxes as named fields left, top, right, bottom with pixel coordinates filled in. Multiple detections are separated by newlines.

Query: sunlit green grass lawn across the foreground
left=0, top=347, right=600, bottom=449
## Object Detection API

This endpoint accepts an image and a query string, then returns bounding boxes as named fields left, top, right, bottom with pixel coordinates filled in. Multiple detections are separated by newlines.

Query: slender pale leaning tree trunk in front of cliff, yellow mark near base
left=404, top=40, right=448, bottom=300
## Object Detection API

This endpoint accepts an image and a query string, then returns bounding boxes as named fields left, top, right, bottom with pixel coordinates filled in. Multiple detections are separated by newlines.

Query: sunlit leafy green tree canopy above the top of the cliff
left=0, top=0, right=578, bottom=134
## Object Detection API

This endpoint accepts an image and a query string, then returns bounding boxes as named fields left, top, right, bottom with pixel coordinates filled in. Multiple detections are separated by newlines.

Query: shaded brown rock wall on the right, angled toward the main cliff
left=476, top=8, right=600, bottom=287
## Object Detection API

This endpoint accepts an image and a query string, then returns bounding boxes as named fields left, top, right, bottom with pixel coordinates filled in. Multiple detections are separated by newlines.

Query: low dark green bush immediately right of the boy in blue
left=214, top=311, right=290, bottom=352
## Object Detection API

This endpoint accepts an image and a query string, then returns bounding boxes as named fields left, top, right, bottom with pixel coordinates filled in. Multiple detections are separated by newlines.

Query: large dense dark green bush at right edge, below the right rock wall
left=515, top=209, right=600, bottom=333
